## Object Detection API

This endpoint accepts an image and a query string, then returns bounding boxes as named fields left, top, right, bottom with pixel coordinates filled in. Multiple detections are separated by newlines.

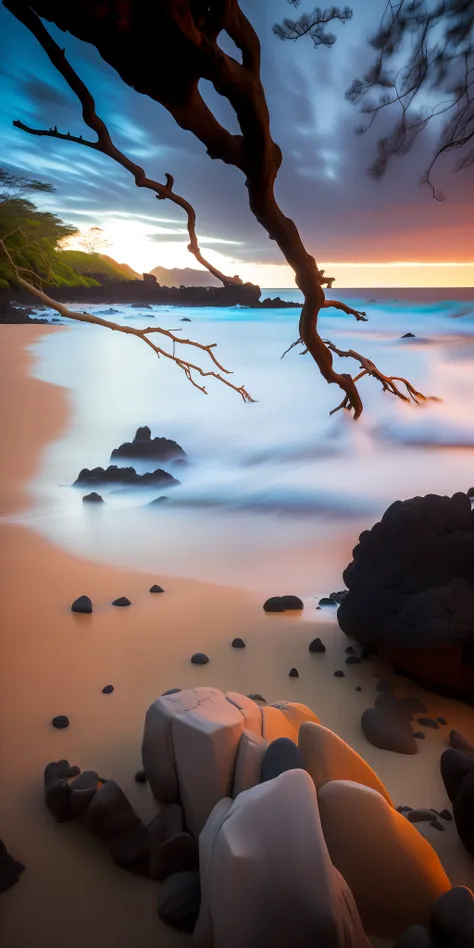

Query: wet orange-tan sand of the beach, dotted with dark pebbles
left=0, top=325, right=474, bottom=948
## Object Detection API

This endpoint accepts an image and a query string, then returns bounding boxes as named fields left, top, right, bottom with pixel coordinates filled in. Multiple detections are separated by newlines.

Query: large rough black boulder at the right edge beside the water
left=338, top=493, right=474, bottom=704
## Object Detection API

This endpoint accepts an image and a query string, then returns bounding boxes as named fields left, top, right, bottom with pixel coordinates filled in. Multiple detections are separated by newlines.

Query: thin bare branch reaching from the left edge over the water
left=0, top=238, right=254, bottom=402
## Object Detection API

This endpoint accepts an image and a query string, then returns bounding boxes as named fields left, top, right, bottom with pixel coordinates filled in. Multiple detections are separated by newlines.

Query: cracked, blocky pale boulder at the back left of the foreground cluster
left=142, top=688, right=318, bottom=836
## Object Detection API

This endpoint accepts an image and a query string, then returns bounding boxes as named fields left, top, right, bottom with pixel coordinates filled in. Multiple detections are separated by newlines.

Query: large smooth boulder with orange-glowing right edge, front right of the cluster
left=318, top=780, right=451, bottom=938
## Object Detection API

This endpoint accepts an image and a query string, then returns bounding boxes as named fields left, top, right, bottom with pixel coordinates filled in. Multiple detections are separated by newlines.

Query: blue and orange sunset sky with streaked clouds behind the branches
left=0, top=0, right=474, bottom=287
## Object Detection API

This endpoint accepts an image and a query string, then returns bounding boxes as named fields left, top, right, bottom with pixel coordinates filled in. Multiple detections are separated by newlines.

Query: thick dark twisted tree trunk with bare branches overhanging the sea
left=0, top=0, right=430, bottom=418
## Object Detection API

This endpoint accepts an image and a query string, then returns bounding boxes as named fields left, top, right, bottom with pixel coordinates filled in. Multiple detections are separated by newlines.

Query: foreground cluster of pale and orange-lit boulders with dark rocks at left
left=41, top=688, right=468, bottom=948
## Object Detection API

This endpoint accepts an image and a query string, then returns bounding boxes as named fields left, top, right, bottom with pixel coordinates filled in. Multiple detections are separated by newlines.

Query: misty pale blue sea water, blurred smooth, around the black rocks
left=13, top=290, right=474, bottom=593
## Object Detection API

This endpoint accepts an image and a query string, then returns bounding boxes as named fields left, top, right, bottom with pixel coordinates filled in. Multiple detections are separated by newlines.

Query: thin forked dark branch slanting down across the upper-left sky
left=9, top=4, right=242, bottom=286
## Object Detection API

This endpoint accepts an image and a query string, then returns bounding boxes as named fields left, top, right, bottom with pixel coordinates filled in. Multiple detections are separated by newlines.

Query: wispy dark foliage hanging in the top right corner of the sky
left=274, top=0, right=474, bottom=201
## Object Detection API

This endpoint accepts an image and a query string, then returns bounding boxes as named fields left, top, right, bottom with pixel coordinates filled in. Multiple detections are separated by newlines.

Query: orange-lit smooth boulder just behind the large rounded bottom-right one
left=298, top=722, right=392, bottom=806
